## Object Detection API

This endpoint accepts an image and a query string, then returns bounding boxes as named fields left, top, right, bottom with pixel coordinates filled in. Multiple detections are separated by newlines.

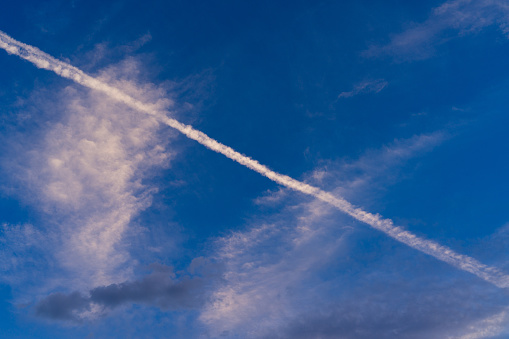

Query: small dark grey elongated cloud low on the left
left=35, top=258, right=221, bottom=321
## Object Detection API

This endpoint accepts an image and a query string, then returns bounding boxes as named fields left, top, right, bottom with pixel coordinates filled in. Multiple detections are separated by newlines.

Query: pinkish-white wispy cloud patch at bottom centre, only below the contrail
left=200, top=197, right=351, bottom=338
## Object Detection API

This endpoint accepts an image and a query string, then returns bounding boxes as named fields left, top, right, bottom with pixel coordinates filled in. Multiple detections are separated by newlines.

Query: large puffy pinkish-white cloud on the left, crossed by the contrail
left=1, top=44, right=176, bottom=293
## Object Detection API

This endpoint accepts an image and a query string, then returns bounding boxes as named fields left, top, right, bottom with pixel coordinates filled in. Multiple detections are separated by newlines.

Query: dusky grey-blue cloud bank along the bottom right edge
left=276, top=283, right=505, bottom=339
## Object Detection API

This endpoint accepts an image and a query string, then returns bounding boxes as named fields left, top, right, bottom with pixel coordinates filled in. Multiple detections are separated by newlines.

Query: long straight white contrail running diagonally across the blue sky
left=0, top=31, right=509, bottom=288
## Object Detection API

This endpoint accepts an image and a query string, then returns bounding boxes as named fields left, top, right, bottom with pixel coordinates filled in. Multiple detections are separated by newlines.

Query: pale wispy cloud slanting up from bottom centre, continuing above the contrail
left=200, top=132, right=443, bottom=338
